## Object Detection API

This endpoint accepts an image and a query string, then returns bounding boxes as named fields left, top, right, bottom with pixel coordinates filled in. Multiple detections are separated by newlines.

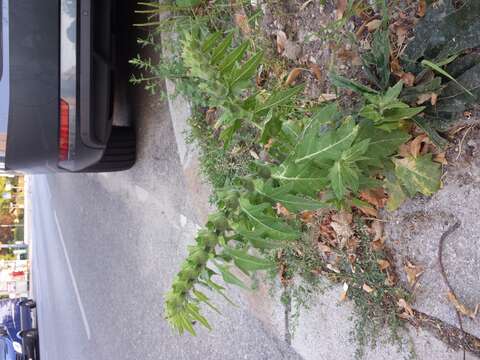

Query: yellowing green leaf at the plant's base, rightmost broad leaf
left=395, top=154, right=442, bottom=196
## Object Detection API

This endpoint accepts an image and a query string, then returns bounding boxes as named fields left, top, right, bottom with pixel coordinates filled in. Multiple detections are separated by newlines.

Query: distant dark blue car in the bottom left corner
left=0, top=299, right=40, bottom=360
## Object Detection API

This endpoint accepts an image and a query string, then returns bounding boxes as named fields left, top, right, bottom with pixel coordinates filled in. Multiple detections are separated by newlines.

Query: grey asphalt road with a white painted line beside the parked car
left=30, top=48, right=297, bottom=360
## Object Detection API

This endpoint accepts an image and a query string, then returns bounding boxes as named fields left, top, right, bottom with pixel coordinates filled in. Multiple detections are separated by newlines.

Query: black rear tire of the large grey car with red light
left=86, top=126, right=136, bottom=172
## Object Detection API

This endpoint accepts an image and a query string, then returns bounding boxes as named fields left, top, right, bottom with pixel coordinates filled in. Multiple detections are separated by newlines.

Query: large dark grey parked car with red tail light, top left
left=0, top=0, right=136, bottom=173
